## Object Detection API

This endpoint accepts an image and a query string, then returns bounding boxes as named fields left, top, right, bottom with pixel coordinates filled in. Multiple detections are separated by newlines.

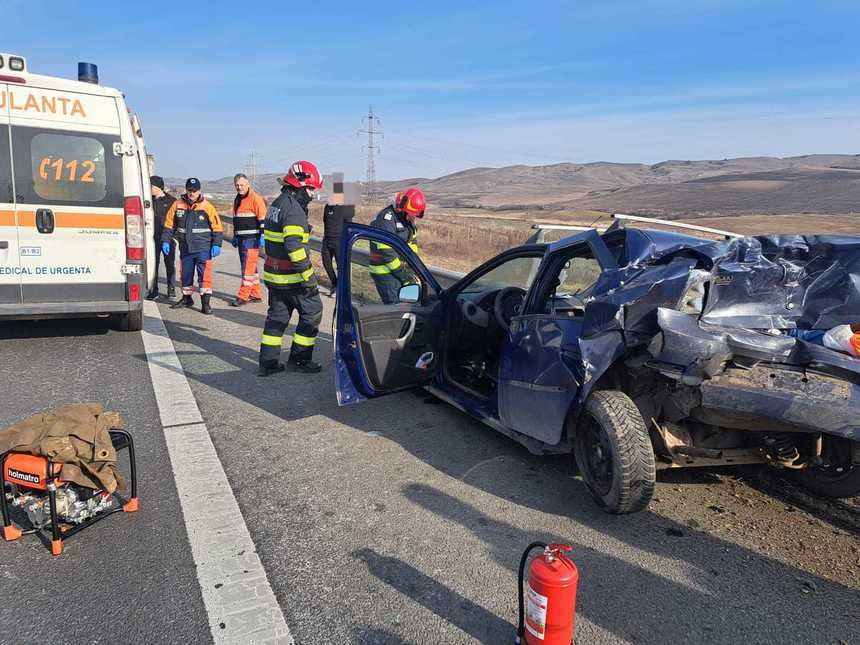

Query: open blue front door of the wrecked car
left=334, top=224, right=443, bottom=405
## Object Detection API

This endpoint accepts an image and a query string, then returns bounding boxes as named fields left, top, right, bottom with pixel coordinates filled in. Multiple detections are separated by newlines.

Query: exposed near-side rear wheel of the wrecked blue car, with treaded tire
left=574, top=390, right=657, bottom=514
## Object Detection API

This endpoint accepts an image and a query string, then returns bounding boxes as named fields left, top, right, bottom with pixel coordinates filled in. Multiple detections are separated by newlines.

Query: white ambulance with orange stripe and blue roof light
left=0, top=53, right=156, bottom=335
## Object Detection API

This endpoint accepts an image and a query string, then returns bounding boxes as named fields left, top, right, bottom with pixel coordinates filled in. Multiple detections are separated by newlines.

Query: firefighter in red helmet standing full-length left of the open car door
left=259, top=161, right=323, bottom=376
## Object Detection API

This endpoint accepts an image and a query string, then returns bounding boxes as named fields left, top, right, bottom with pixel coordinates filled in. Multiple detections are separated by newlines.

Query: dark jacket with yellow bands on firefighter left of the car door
left=263, top=187, right=316, bottom=289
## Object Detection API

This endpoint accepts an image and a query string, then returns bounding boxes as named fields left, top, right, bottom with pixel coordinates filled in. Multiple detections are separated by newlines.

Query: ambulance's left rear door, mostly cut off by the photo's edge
left=0, top=83, right=21, bottom=305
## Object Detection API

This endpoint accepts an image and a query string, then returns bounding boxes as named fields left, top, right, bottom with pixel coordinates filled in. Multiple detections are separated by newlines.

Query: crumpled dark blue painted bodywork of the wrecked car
left=335, top=225, right=860, bottom=452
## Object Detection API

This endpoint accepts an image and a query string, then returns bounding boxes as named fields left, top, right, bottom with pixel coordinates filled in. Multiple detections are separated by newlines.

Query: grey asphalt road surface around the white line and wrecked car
left=0, top=247, right=860, bottom=643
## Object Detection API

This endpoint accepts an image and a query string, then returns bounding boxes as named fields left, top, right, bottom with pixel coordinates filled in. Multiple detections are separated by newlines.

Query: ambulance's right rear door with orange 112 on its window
left=9, top=86, right=126, bottom=311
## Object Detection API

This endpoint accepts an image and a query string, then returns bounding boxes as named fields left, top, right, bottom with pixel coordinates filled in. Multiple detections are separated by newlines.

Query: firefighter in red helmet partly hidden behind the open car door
left=368, top=187, right=427, bottom=304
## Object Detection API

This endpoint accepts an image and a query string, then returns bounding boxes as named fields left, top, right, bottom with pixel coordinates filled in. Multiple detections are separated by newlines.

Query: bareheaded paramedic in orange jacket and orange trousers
left=230, top=173, right=266, bottom=307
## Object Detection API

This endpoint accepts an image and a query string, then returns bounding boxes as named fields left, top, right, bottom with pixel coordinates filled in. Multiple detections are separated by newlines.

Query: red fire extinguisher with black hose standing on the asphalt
left=516, top=542, right=579, bottom=645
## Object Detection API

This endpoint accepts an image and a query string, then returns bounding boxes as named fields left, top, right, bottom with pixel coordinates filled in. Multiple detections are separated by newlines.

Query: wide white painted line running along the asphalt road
left=141, top=301, right=295, bottom=645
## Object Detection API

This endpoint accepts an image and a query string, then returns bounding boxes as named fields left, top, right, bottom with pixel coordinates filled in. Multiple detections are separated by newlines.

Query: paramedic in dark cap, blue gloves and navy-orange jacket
left=161, top=177, right=224, bottom=314
